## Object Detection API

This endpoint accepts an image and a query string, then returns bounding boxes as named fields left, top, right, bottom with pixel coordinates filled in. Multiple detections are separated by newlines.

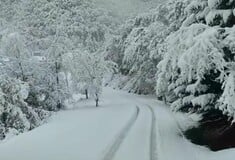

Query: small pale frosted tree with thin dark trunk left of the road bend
left=64, top=51, right=115, bottom=106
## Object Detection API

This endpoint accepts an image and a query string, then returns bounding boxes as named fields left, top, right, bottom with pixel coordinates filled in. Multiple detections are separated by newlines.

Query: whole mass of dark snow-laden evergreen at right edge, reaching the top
left=156, top=0, right=235, bottom=118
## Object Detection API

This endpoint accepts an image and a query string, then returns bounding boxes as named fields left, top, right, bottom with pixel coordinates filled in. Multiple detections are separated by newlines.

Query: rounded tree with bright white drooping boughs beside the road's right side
left=157, top=24, right=226, bottom=110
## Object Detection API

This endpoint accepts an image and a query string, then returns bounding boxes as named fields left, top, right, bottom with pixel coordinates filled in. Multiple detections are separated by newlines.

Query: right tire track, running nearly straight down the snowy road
left=147, top=105, right=158, bottom=160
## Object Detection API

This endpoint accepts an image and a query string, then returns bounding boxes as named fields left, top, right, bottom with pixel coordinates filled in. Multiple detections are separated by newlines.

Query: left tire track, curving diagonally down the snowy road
left=102, top=106, right=140, bottom=160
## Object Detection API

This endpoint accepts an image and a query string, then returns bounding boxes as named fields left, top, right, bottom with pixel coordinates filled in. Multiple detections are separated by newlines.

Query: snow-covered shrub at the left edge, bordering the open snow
left=0, top=76, right=49, bottom=139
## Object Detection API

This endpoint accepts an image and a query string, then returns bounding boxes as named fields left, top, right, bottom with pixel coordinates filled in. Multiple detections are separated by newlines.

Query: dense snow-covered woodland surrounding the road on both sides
left=0, top=0, right=235, bottom=150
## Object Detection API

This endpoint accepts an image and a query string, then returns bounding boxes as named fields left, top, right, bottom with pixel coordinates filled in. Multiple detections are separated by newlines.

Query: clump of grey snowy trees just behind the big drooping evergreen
left=106, top=0, right=188, bottom=94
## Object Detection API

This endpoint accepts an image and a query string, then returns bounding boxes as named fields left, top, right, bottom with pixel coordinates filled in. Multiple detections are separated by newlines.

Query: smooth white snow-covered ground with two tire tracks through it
left=0, top=88, right=235, bottom=160
